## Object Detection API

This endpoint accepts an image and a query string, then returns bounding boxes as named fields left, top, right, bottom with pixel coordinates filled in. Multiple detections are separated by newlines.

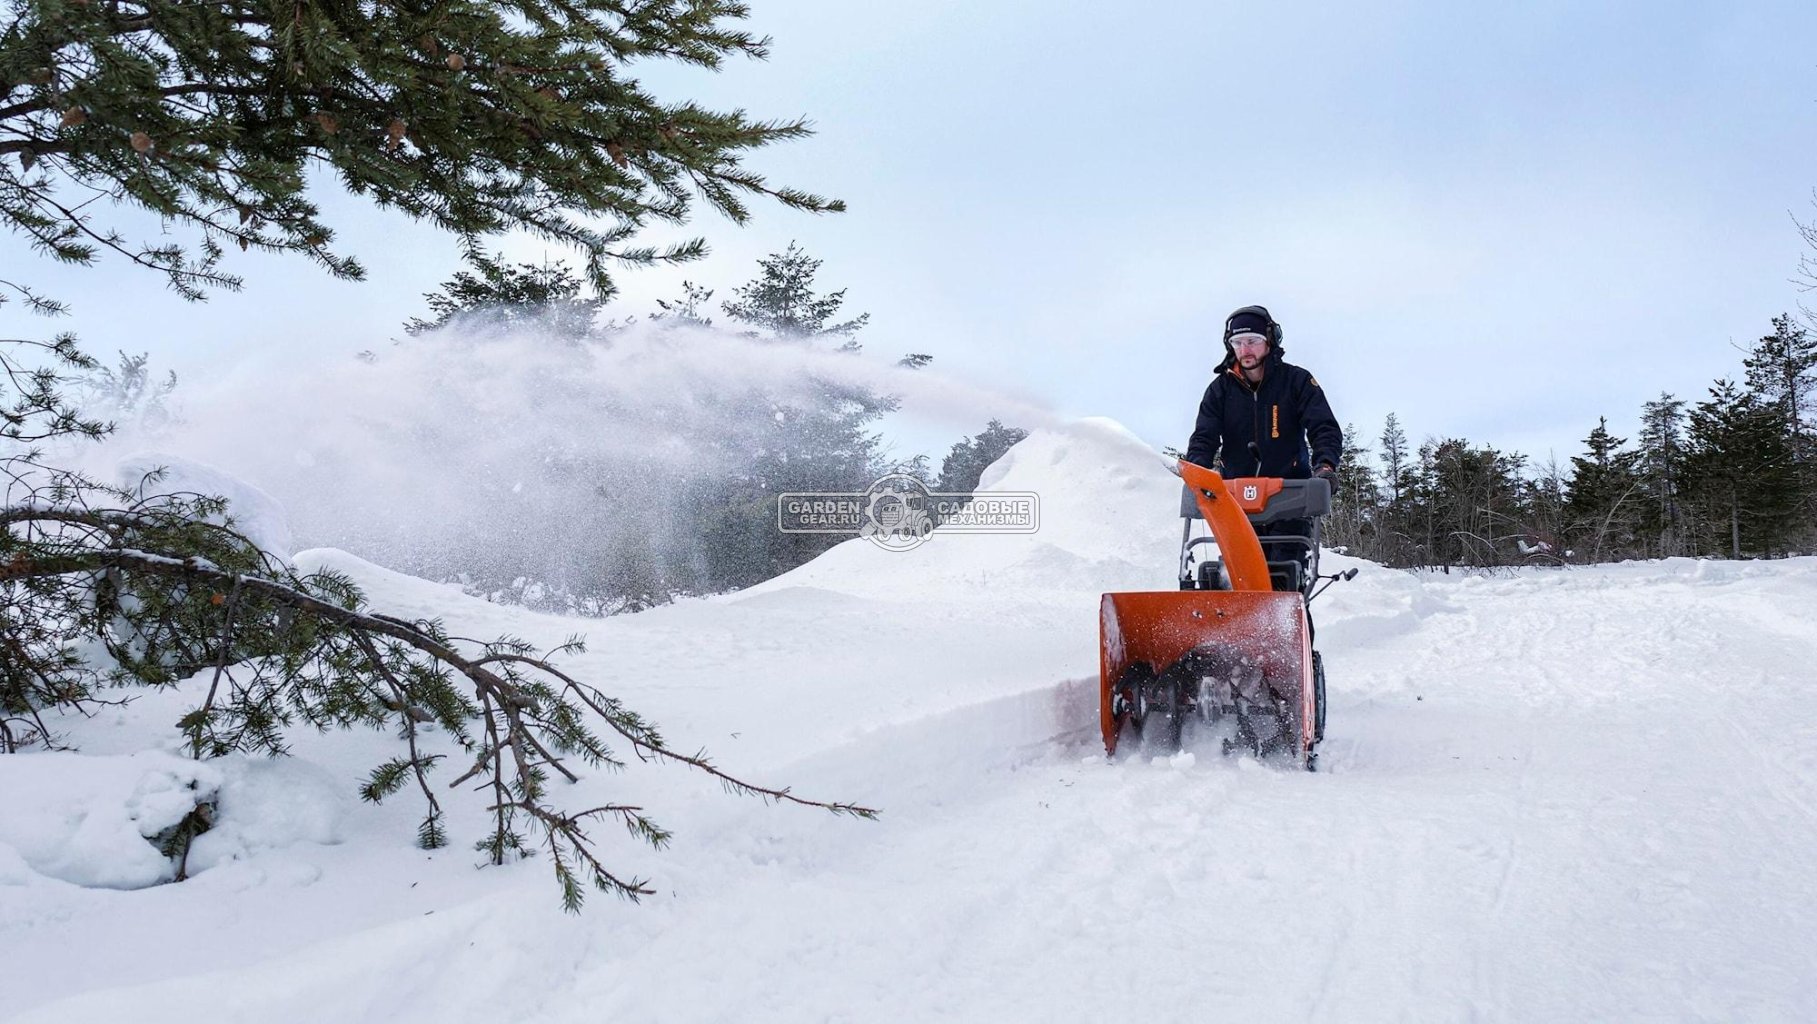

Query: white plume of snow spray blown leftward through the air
left=92, top=321, right=1056, bottom=614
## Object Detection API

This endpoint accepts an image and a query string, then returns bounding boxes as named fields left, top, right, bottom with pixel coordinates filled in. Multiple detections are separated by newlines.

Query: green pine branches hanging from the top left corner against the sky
left=0, top=0, right=843, bottom=294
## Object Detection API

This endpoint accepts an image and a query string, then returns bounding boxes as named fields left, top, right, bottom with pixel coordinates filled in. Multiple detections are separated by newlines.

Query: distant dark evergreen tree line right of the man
left=1326, top=314, right=1817, bottom=566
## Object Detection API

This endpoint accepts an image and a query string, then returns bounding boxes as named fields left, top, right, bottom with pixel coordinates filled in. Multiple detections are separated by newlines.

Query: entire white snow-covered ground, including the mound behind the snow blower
left=0, top=421, right=1817, bottom=1024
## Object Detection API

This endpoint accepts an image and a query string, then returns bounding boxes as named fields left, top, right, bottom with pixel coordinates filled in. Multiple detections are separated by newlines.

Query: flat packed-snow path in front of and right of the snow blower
left=549, top=559, right=1817, bottom=1020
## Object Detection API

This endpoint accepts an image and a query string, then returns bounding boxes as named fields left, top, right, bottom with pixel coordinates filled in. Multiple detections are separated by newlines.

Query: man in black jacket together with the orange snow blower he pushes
left=1097, top=305, right=1355, bottom=770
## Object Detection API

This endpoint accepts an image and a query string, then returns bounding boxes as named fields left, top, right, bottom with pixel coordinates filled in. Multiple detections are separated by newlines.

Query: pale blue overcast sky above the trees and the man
left=0, top=0, right=1817, bottom=459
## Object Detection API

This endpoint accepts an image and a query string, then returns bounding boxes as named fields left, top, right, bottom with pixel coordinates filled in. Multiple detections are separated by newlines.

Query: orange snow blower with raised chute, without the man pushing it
left=1099, top=461, right=1355, bottom=772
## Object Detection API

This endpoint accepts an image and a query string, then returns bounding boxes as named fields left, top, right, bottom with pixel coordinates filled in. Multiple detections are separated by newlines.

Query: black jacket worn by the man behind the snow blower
left=1187, top=350, right=1345, bottom=479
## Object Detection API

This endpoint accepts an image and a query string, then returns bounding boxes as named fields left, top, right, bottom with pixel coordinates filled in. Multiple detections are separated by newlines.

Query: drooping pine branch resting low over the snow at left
left=0, top=503, right=876, bottom=910
